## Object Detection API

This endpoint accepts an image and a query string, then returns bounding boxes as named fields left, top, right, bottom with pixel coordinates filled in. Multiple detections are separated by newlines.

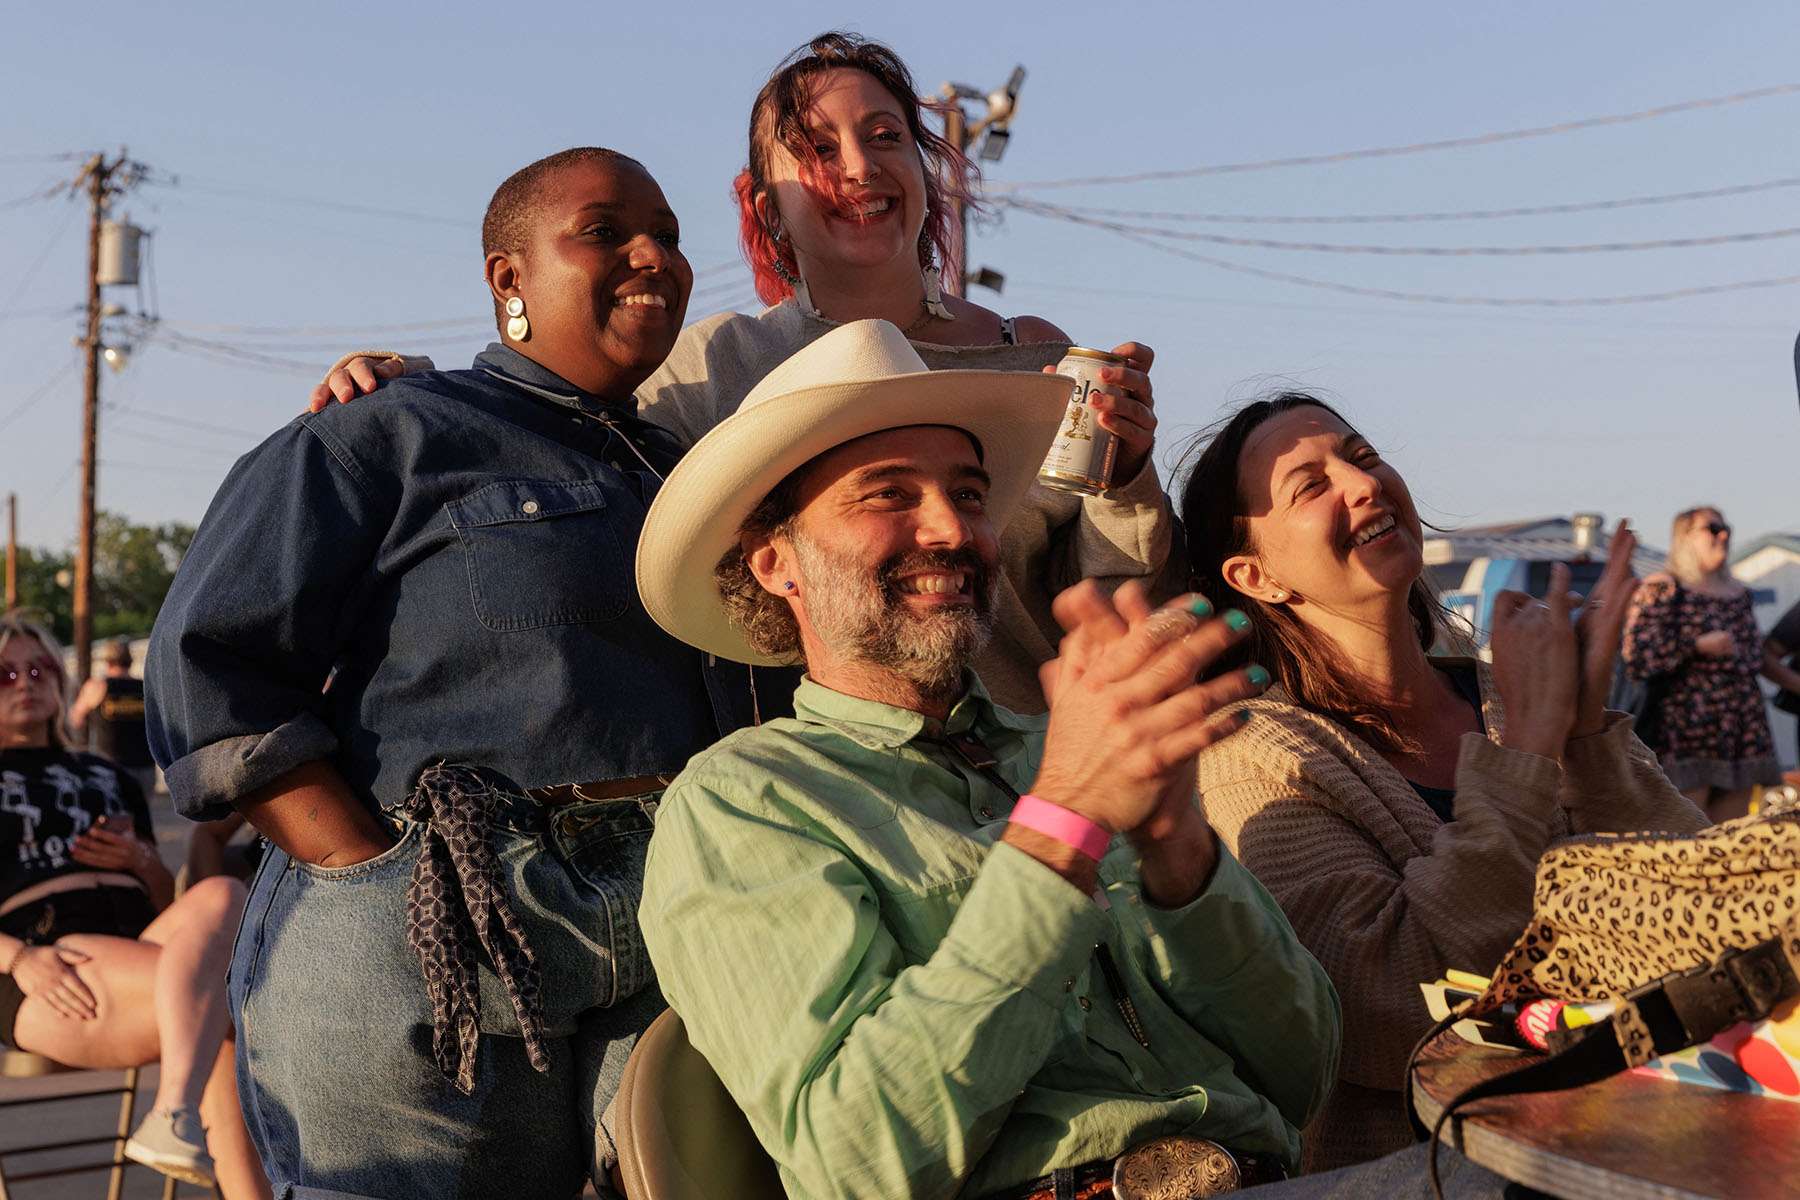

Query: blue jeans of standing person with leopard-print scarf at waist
left=229, top=795, right=662, bottom=1200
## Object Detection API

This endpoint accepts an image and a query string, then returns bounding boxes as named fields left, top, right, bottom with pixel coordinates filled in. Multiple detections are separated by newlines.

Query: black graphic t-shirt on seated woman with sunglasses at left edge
left=0, top=748, right=155, bottom=900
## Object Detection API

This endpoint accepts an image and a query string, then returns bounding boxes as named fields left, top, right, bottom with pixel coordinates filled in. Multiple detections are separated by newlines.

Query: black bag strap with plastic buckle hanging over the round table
left=1406, top=919, right=1800, bottom=1200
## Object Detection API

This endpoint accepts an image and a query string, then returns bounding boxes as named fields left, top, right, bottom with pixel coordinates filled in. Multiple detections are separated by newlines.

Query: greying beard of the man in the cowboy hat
left=794, top=534, right=994, bottom=696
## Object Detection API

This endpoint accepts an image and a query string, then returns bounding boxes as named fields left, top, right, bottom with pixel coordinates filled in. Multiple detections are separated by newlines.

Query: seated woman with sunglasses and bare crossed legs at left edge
left=0, top=615, right=268, bottom=1196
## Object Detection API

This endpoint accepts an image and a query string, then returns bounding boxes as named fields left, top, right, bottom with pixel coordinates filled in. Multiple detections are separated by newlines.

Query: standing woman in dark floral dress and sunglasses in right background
left=1624, top=504, right=1782, bottom=822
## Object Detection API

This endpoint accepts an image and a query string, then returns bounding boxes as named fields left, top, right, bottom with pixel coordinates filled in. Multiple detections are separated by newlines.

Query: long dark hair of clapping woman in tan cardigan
left=1181, top=392, right=1462, bottom=754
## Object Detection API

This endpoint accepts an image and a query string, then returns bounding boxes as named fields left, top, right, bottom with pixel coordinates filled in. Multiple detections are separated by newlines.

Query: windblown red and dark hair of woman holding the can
left=733, top=31, right=979, bottom=304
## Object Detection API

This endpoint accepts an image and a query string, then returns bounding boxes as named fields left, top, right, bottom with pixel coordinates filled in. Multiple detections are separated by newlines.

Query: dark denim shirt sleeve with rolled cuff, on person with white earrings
left=144, top=417, right=394, bottom=820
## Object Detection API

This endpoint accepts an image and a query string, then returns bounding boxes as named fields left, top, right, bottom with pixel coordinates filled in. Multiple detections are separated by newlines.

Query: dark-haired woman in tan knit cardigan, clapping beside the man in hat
left=1181, top=392, right=1705, bottom=1171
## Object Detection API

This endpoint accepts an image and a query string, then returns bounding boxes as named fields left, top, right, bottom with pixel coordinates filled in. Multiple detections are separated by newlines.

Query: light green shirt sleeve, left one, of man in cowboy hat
left=639, top=766, right=1105, bottom=1196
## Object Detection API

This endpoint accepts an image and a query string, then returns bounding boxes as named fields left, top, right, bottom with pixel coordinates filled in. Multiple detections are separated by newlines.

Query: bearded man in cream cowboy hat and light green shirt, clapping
left=637, top=320, right=1339, bottom=1196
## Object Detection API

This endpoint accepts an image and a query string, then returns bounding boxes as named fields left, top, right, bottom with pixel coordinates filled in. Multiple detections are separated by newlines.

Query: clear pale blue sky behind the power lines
left=0, top=0, right=1800, bottom=547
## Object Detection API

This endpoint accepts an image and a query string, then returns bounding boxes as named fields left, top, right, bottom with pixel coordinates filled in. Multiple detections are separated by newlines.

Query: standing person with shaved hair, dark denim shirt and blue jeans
left=148, top=148, right=756, bottom=1200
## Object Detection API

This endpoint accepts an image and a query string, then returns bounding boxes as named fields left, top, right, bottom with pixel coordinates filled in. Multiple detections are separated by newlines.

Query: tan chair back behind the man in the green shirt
left=612, top=1009, right=787, bottom=1200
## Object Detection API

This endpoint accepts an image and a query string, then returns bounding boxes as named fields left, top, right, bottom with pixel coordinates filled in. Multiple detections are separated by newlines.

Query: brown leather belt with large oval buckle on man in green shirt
left=986, top=1133, right=1287, bottom=1200
